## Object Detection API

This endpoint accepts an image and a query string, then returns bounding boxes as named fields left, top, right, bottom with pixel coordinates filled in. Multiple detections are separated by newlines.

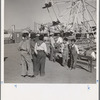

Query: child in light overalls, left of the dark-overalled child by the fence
left=61, top=38, right=69, bottom=66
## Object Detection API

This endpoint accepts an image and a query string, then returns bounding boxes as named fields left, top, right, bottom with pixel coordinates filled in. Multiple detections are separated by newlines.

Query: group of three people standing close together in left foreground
left=18, top=31, right=47, bottom=77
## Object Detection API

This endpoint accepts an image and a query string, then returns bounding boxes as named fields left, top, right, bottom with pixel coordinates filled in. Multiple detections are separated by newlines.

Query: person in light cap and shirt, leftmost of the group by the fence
left=50, top=33, right=55, bottom=61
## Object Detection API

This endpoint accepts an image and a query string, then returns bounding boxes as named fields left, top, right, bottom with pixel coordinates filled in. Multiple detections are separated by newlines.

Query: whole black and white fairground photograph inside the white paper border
left=3, top=0, right=98, bottom=84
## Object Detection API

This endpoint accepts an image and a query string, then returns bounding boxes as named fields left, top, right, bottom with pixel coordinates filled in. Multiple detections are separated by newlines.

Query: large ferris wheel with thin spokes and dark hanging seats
left=43, top=0, right=96, bottom=32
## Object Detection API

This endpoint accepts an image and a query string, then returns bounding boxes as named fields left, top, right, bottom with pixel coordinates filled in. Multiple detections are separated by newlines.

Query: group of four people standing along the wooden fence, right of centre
left=50, top=33, right=79, bottom=69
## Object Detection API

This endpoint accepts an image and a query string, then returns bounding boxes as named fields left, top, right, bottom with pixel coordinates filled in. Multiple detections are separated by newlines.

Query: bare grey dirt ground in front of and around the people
left=4, top=44, right=96, bottom=84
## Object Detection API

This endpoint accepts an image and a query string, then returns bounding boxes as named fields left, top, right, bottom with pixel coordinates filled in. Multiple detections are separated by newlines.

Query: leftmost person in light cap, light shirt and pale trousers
left=18, top=32, right=34, bottom=77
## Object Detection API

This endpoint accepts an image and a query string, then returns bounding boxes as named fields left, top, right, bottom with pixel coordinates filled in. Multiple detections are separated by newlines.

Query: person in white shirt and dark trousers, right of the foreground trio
left=34, top=35, right=47, bottom=76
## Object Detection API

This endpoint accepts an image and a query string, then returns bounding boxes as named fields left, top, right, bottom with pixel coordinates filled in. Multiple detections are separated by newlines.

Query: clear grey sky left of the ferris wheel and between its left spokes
left=4, top=0, right=94, bottom=29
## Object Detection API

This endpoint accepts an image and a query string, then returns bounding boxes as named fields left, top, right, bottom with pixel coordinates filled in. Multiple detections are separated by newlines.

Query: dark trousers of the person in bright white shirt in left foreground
left=36, top=50, right=46, bottom=76
